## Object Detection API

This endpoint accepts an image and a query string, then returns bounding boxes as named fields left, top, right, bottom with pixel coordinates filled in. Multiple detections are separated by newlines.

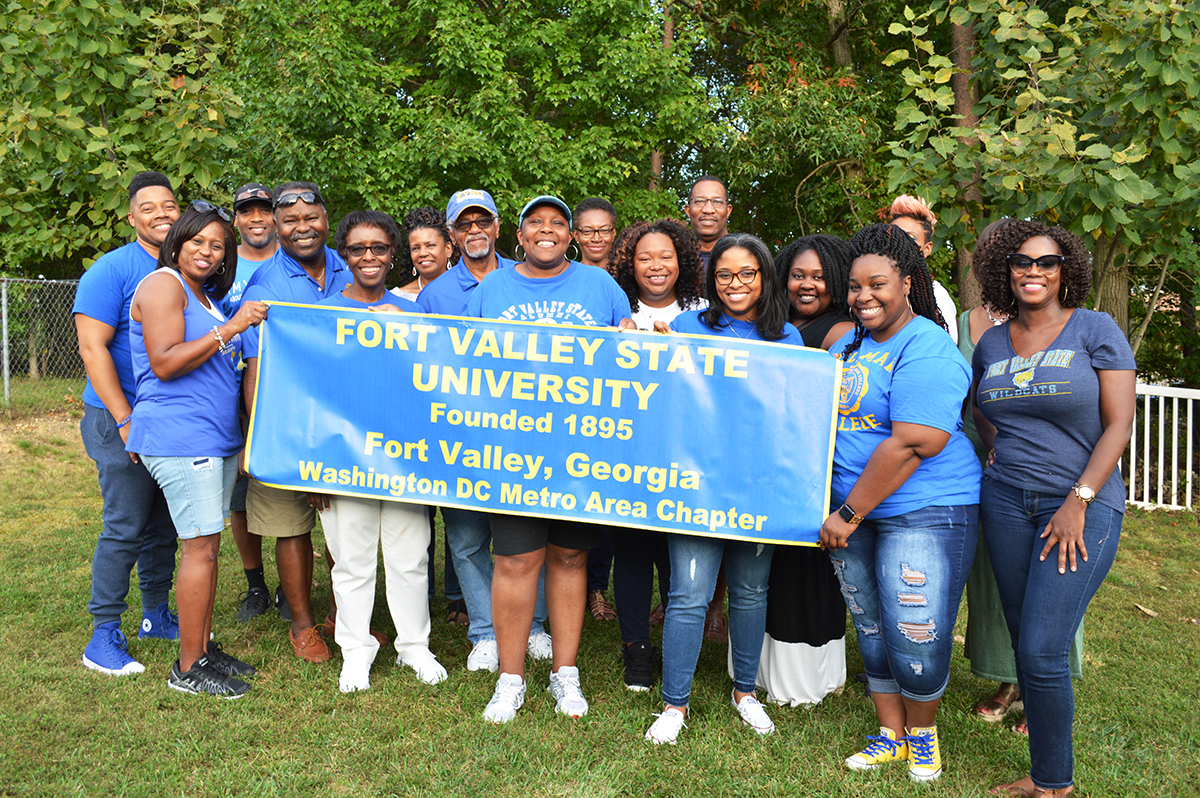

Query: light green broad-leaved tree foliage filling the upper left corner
left=0, top=0, right=239, bottom=276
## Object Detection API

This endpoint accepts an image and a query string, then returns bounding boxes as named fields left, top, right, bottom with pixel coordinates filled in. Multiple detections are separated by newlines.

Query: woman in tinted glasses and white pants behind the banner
left=310, top=210, right=446, bottom=692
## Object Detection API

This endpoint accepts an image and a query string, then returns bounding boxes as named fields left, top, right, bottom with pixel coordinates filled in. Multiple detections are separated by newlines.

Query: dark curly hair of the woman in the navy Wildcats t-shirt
left=971, top=220, right=1092, bottom=317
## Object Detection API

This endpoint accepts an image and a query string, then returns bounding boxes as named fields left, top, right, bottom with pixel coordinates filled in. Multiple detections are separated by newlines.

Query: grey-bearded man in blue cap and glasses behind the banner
left=416, top=188, right=551, bottom=672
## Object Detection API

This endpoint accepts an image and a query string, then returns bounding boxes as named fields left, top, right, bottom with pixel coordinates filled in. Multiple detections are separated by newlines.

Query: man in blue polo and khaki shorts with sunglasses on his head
left=242, top=182, right=352, bottom=662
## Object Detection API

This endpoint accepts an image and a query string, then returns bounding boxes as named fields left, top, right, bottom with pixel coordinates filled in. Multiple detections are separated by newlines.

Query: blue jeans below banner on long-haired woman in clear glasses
left=662, top=534, right=775, bottom=707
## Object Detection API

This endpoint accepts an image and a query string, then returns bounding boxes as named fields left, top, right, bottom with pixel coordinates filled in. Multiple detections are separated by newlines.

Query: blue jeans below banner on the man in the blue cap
left=442, top=508, right=547, bottom=646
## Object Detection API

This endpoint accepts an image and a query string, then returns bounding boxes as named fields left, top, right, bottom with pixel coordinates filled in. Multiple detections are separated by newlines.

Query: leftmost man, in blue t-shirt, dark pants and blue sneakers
left=72, top=172, right=179, bottom=676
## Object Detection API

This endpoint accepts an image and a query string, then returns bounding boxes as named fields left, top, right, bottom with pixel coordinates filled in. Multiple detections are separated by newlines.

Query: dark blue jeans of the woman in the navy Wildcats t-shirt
left=979, top=474, right=1123, bottom=790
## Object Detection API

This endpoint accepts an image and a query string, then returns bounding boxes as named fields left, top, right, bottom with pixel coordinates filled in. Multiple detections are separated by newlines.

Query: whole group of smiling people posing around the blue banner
left=74, top=173, right=1135, bottom=796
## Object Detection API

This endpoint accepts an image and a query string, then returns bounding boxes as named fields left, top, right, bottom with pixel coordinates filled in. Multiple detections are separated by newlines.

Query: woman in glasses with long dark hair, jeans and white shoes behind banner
left=646, top=233, right=802, bottom=745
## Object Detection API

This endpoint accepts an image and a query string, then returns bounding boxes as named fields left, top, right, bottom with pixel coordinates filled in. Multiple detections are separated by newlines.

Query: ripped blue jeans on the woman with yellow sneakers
left=829, top=504, right=979, bottom=701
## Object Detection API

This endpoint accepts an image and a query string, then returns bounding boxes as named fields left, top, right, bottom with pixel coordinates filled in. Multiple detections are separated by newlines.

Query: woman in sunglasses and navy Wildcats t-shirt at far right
left=972, top=221, right=1136, bottom=796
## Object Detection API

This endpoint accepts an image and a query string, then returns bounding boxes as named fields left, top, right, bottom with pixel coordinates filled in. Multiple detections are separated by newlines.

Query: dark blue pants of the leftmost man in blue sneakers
left=79, top=404, right=179, bottom=626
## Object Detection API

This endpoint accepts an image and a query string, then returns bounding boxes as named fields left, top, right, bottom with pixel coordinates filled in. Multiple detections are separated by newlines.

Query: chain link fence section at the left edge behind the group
left=0, top=278, right=85, bottom=418
